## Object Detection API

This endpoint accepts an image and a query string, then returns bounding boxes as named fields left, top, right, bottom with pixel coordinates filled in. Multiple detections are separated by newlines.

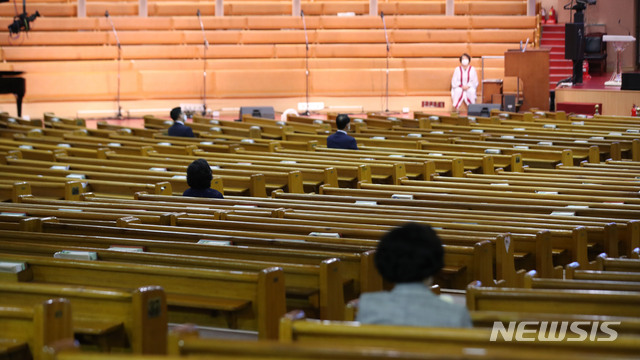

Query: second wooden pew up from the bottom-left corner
left=0, top=282, right=167, bottom=354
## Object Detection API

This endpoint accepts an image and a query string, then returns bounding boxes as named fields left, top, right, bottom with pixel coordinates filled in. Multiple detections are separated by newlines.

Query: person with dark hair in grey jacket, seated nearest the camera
left=356, top=223, right=471, bottom=327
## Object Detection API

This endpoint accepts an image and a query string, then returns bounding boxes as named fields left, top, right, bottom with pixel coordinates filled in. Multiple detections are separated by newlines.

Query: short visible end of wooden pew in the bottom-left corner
left=0, top=298, right=75, bottom=360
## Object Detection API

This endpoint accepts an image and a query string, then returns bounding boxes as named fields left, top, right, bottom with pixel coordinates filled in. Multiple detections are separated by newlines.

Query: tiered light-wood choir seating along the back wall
left=0, top=4, right=537, bottom=101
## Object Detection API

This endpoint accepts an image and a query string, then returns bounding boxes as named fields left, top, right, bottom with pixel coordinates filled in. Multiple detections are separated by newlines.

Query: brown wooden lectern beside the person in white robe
left=504, top=49, right=549, bottom=111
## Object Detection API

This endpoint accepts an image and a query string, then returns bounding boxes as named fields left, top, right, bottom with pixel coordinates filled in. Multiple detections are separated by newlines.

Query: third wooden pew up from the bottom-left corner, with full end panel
left=2, top=254, right=286, bottom=338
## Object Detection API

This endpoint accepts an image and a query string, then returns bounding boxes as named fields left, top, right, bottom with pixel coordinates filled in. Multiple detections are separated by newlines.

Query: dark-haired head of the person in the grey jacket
left=374, top=223, right=444, bottom=283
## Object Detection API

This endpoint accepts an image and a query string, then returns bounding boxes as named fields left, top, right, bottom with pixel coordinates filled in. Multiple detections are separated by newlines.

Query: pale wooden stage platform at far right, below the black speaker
left=556, top=74, right=640, bottom=116
